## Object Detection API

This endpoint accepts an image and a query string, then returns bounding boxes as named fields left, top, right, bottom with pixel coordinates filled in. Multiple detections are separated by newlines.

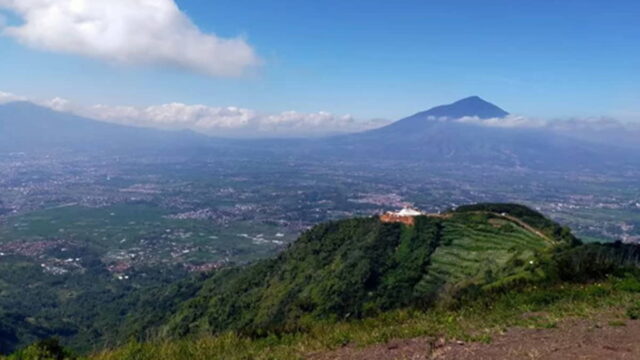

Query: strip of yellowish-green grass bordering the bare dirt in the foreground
left=84, top=279, right=640, bottom=360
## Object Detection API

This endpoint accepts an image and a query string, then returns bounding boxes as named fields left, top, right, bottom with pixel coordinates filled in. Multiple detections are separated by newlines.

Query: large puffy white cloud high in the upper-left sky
left=0, top=0, right=260, bottom=76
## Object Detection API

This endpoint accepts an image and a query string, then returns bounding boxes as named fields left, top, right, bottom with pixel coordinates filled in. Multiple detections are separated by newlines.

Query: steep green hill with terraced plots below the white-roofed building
left=127, top=205, right=577, bottom=336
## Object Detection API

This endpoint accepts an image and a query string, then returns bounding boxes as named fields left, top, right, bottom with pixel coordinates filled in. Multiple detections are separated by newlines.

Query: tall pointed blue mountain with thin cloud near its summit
left=324, top=96, right=637, bottom=170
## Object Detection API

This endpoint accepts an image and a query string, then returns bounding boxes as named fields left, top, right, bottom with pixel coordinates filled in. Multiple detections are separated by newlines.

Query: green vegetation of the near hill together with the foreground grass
left=5, top=204, right=640, bottom=360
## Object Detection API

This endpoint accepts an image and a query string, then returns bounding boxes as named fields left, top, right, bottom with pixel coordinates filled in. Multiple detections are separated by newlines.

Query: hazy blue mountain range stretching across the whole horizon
left=0, top=96, right=639, bottom=169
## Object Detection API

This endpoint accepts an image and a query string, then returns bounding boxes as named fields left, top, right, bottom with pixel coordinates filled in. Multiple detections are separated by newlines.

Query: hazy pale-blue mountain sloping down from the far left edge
left=0, top=102, right=209, bottom=152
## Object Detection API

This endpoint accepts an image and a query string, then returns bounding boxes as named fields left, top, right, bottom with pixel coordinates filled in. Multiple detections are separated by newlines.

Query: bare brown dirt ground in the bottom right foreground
left=308, top=319, right=640, bottom=360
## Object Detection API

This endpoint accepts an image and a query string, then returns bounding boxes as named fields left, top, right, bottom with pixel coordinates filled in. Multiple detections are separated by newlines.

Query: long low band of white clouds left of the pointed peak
left=0, top=92, right=389, bottom=137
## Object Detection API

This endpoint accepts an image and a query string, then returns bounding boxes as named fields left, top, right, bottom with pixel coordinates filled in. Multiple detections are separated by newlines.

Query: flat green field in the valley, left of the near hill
left=0, top=204, right=295, bottom=263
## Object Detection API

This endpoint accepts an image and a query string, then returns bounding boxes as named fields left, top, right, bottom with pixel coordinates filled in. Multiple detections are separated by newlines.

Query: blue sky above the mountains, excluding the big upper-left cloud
left=0, top=0, right=640, bottom=126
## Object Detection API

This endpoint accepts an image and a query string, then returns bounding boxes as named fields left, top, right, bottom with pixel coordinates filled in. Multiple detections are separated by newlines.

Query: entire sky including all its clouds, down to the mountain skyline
left=0, top=0, right=640, bottom=137
